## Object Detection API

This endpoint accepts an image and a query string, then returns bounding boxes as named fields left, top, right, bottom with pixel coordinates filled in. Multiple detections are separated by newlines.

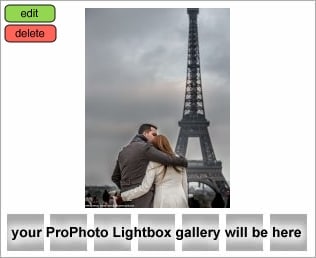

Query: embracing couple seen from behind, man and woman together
left=112, top=124, right=188, bottom=208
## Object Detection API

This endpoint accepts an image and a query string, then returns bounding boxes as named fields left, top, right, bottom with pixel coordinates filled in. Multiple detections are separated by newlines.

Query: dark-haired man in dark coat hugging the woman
left=112, top=124, right=188, bottom=208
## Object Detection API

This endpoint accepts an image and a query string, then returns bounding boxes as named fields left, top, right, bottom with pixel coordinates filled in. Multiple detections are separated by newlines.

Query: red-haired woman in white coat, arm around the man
left=121, top=135, right=188, bottom=208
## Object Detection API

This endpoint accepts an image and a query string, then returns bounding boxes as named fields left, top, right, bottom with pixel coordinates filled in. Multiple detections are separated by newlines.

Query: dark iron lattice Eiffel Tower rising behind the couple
left=175, top=8, right=229, bottom=207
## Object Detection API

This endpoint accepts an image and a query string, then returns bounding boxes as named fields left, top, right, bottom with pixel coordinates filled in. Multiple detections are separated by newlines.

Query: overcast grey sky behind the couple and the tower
left=85, top=8, right=230, bottom=185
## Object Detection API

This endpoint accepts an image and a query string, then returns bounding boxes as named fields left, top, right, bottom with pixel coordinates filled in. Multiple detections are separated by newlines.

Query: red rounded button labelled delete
left=4, top=25, right=56, bottom=42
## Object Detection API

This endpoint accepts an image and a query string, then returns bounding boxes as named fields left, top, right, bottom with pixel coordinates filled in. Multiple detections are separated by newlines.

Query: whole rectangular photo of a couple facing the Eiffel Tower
left=85, top=8, right=230, bottom=208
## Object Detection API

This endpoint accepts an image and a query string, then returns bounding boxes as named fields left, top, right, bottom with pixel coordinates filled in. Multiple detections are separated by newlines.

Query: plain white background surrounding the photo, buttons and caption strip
left=1, top=1, right=315, bottom=257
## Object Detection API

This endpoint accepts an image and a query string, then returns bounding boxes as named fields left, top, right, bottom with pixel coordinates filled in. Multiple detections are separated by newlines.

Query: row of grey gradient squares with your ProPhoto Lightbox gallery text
left=7, top=214, right=307, bottom=251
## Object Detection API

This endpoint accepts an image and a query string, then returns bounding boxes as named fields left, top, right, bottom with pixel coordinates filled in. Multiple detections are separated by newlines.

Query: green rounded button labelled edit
left=4, top=4, right=55, bottom=22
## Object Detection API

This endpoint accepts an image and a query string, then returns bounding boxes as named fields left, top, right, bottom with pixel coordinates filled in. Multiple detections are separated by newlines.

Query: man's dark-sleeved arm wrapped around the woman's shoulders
left=145, top=144, right=188, bottom=167
